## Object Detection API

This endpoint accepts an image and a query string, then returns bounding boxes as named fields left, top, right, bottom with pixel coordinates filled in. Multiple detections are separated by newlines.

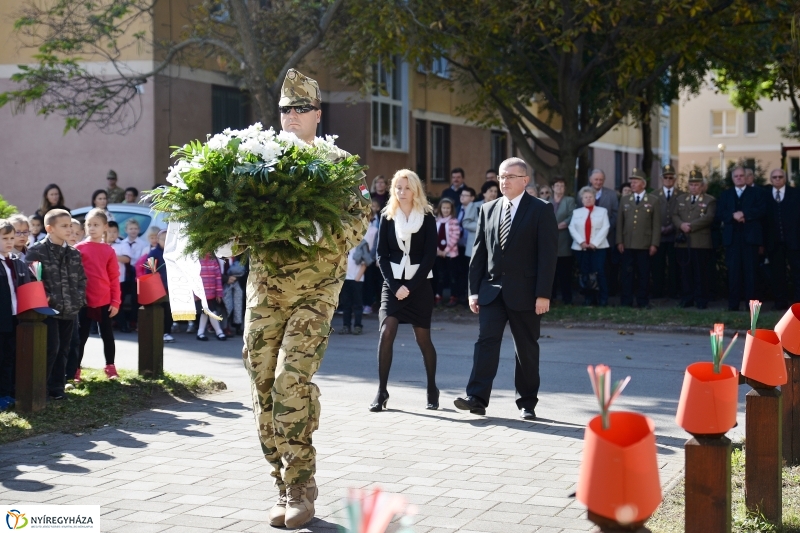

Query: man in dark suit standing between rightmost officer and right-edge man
left=716, top=166, right=766, bottom=311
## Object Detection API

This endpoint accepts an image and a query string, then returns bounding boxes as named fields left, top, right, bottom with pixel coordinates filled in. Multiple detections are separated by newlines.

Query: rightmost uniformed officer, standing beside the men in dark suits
left=672, top=170, right=717, bottom=309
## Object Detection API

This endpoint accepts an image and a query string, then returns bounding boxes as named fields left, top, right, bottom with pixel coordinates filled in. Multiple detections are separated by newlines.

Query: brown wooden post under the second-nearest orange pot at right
left=684, top=435, right=731, bottom=533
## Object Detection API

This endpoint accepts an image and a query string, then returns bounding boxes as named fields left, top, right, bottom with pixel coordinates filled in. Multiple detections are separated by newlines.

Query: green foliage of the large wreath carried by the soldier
left=147, top=129, right=365, bottom=268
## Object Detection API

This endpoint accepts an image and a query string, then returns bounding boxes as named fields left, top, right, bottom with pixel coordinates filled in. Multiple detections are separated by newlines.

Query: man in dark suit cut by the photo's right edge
left=764, top=168, right=800, bottom=310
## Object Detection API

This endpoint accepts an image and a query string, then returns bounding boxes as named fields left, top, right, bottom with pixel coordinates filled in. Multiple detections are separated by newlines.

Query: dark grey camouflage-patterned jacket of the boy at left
left=25, top=237, right=86, bottom=320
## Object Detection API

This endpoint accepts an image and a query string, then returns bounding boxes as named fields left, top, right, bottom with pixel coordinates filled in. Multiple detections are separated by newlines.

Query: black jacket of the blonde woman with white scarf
left=378, top=214, right=438, bottom=293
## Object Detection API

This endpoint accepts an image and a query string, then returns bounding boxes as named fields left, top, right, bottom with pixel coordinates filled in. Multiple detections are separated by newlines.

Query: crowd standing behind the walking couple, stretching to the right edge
left=345, top=165, right=800, bottom=318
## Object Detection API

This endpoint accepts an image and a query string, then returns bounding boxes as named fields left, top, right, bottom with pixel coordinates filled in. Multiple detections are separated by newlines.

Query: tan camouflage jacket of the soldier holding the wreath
left=246, top=144, right=371, bottom=308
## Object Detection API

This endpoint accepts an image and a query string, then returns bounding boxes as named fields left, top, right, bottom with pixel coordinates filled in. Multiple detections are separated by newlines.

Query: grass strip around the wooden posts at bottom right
left=646, top=443, right=800, bottom=533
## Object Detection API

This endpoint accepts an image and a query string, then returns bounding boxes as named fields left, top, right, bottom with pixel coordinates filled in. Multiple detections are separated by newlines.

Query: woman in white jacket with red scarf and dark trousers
left=569, top=187, right=611, bottom=307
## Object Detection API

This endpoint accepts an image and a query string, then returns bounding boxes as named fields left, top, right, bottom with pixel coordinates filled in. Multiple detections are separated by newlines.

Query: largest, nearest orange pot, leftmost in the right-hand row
left=577, top=412, right=661, bottom=524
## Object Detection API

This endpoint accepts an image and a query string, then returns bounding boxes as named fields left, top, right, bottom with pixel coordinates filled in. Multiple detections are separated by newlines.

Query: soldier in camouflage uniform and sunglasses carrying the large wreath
left=242, top=69, right=370, bottom=528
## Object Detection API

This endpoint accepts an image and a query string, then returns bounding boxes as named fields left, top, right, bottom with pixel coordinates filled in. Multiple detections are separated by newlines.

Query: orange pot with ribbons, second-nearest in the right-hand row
left=675, top=362, right=739, bottom=435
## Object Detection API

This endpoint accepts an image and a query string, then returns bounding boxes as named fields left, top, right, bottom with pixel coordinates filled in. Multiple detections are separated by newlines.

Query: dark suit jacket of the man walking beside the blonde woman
left=469, top=193, right=558, bottom=311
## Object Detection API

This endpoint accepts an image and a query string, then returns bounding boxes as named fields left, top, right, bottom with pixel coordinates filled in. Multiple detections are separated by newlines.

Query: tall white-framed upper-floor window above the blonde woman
left=372, top=56, right=408, bottom=150
